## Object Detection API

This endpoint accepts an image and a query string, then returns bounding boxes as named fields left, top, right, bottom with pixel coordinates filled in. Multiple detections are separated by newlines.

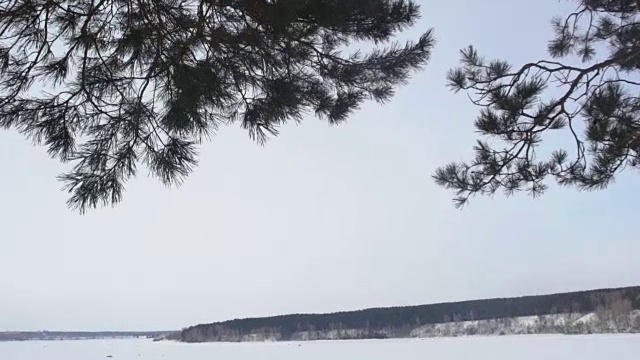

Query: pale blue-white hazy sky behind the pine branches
left=0, top=0, right=640, bottom=331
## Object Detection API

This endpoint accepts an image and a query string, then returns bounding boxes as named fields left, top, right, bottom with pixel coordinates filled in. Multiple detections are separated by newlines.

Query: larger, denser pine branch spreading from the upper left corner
left=0, top=0, right=433, bottom=212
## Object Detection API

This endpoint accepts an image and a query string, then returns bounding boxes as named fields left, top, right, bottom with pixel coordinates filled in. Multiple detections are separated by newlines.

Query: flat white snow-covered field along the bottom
left=0, top=335, right=640, bottom=360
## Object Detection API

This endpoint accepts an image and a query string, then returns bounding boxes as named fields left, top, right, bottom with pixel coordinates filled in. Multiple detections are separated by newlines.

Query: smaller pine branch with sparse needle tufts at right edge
left=433, top=0, right=640, bottom=207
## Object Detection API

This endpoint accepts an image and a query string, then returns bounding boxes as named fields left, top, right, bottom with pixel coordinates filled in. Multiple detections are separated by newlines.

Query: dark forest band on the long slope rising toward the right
left=181, top=286, right=640, bottom=342
